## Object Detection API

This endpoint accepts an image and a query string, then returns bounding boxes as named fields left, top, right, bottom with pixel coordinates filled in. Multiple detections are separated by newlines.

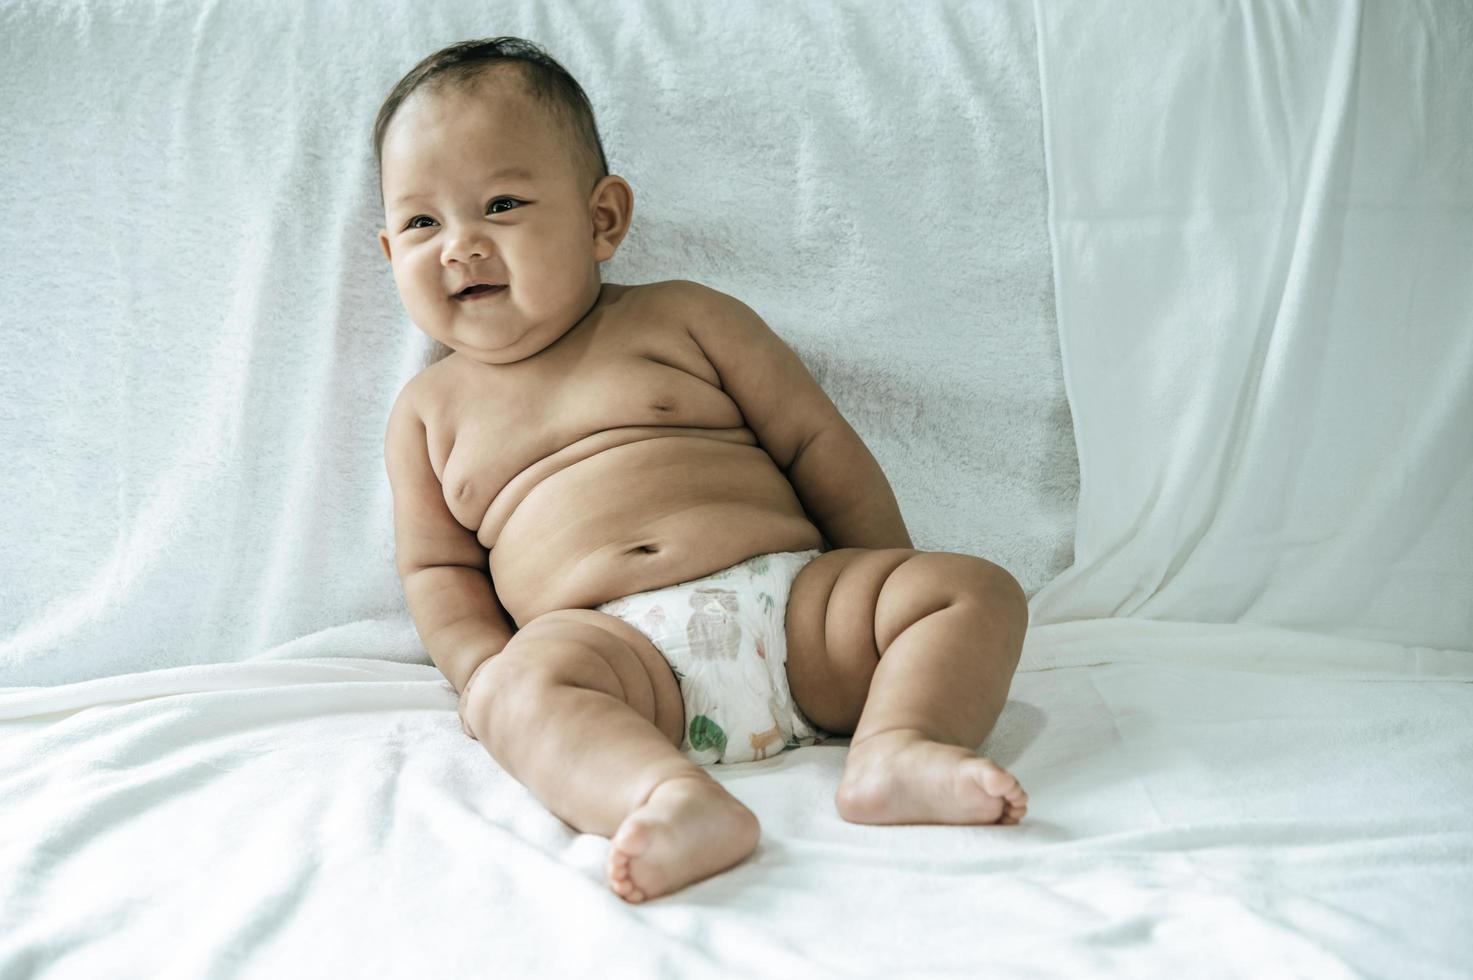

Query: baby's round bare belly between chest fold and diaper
left=491, top=436, right=823, bottom=626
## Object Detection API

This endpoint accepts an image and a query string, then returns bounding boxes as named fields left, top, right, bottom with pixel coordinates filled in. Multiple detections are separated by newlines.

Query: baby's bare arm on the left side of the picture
left=383, top=389, right=516, bottom=694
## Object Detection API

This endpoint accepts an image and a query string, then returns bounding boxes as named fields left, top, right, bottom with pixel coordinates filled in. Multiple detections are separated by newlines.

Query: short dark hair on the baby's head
left=373, top=37, right=608, bottom=201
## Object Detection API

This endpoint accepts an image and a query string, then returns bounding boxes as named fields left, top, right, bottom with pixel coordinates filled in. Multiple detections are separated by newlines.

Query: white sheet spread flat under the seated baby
left=0, top=619, right=1473, bottom=980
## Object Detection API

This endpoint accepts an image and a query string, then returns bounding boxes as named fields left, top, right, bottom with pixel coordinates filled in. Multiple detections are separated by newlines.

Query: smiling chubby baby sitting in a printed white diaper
left=374, top=38, right=1028, bottom=902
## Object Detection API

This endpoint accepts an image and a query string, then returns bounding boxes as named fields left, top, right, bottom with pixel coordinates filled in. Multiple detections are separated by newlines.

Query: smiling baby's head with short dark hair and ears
left=374, top=37, right=633, bottom=364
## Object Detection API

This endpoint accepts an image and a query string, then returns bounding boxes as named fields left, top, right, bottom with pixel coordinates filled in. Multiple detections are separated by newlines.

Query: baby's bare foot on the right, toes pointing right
left=834, top=729, right=1028, bottom=824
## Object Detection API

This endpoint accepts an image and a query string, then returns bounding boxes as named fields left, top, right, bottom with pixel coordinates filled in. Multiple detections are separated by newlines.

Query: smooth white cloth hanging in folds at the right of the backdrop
left=1033, top=0, right=1473, bottom=650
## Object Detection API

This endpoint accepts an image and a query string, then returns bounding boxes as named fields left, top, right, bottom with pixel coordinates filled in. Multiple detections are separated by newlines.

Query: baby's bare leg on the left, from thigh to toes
left=461, top=609, right=759, bottom=902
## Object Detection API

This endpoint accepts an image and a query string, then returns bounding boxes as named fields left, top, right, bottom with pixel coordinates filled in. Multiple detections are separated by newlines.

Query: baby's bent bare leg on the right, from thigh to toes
left=787, top=548, right=1028, bottom=824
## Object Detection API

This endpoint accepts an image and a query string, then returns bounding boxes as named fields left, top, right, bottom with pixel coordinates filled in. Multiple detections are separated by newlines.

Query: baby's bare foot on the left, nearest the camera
left=605, top=775, right=760, bottom=902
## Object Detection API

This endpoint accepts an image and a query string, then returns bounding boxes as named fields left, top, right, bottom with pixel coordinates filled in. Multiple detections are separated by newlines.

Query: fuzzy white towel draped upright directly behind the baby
left=0, top=0, right=1077, bottom=687
